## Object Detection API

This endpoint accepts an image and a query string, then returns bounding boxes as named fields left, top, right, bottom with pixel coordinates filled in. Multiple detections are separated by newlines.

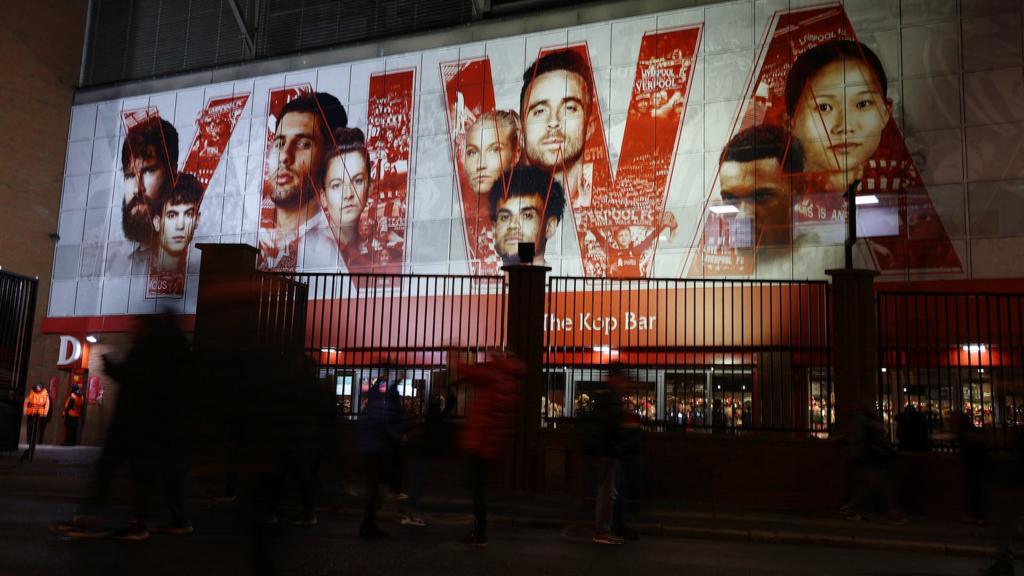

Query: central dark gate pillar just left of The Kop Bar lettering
left=502, top=264, right=551, bottom=490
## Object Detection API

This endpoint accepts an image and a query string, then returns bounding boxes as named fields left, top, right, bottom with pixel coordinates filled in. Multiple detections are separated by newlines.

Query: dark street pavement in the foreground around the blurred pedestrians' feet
left=0, top=447, right=1024, bottom=575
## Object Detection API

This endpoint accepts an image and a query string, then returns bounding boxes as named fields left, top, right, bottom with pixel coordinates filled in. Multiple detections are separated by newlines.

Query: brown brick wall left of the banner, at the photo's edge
left=0, top=0, right=87, bottom=443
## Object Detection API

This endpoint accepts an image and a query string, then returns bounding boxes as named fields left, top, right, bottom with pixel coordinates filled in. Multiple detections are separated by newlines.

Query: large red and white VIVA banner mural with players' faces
left=50, top=2, right=1003, bottom=317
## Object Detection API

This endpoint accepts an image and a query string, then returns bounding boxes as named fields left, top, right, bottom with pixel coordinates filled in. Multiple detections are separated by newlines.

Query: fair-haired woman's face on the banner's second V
left=462, top=118, right=519, bottom=194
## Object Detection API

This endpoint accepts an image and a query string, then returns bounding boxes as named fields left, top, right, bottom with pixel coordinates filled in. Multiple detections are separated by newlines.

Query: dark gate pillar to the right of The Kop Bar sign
left=825, top=270, right=879, bottom=434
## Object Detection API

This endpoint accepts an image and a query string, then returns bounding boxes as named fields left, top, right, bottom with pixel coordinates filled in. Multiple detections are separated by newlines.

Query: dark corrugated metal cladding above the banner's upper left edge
left=83, top=0, right=516, bottom=86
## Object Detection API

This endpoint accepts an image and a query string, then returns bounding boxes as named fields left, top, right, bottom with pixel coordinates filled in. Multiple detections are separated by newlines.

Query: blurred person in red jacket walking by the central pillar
left=457, top=353, right=525, bottom=546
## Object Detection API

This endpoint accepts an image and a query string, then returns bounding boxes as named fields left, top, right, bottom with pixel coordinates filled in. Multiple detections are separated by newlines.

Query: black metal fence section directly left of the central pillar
left=261, top=274, right=507, bottom=414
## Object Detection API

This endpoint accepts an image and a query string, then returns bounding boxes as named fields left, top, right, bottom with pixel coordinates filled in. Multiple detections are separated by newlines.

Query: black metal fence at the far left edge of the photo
left=0, top=270, right=39, bottom=451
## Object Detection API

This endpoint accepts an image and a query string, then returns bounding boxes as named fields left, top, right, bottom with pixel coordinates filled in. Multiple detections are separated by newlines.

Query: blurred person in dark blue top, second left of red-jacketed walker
left=358, top=370, right=401, bottom=540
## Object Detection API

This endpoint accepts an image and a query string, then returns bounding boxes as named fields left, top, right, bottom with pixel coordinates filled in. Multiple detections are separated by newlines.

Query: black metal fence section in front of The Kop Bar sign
left=543, top=278, right=835, bottom=436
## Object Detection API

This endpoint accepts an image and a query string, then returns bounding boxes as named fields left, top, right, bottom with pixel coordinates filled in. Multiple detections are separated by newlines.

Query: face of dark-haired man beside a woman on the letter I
left=270, top=112, right=324, bottom=205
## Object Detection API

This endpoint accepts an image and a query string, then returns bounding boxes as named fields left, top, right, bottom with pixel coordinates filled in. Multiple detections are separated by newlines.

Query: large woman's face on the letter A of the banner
left=793, top=59, right=889, bottom=172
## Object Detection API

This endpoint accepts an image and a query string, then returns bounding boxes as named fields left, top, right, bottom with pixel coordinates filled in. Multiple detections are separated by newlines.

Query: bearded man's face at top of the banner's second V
left=522, top=70, right=590, bottom=172
